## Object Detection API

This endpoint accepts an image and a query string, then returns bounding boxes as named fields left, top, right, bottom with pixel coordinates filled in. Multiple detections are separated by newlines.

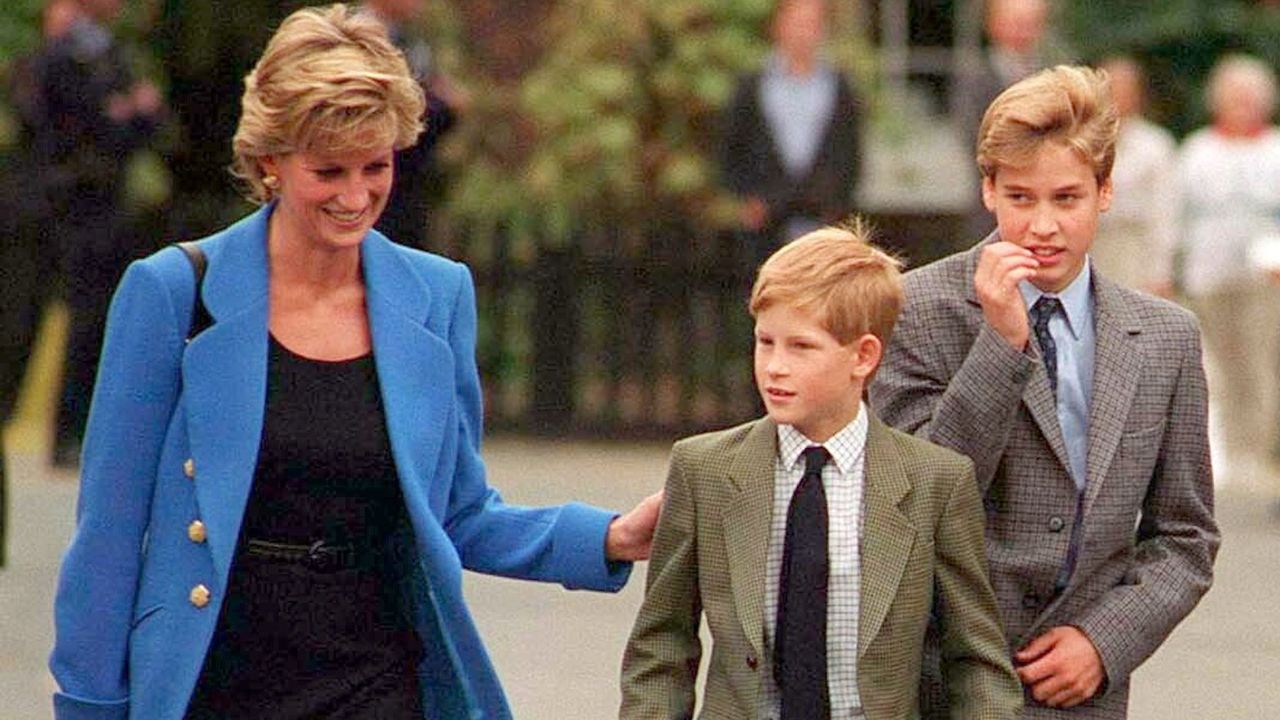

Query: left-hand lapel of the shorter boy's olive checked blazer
left=722, top=419, right=778, bottom=656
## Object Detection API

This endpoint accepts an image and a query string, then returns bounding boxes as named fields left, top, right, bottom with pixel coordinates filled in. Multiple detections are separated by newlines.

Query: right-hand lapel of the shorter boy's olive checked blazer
left=858, top=416, right=916, bottom=657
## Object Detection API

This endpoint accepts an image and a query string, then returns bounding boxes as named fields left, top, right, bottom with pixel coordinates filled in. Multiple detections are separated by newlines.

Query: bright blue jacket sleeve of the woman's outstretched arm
left=444, top=265, right=631, bottom=592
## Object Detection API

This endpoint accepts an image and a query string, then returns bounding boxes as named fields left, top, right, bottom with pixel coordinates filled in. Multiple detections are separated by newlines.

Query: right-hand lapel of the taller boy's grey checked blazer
left=1084, top=273, right=1142, bottom=511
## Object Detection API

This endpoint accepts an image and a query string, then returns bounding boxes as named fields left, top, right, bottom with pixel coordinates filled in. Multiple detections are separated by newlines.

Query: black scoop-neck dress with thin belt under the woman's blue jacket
left=187, top=337, right=424, bottom=720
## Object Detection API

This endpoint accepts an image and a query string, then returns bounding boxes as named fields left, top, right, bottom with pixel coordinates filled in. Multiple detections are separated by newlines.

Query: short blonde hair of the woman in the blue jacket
left=232, top=5, right=426, bottom=202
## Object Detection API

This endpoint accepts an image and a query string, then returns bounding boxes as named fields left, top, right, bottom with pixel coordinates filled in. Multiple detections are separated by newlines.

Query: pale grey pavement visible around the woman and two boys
left=0, top=438, right=1280, bottom=720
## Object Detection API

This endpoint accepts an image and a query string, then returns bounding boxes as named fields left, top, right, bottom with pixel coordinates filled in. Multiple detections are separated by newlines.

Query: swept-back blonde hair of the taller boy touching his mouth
left=978, top=65, right=1120, bottom=184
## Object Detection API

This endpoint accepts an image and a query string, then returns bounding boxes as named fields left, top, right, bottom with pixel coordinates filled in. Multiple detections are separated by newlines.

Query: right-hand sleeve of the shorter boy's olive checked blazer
left=933, top=461, right=1023, bottom=720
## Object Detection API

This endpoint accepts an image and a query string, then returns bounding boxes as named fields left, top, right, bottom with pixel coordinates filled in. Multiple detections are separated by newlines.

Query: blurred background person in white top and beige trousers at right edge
left=1178, top=55, right=1280, bottom=482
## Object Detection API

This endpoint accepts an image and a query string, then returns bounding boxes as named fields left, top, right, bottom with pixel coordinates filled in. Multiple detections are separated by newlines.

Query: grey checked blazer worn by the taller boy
left=870, top=236, right=1220, bottom=719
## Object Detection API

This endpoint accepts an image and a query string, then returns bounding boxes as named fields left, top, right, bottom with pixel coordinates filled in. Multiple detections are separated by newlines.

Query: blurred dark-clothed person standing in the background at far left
left=35, top=0, right=161, bottom=466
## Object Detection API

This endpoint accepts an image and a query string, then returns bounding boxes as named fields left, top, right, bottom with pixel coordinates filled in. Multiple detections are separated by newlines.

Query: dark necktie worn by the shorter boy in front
left=773, top=446, right=831, bottom=720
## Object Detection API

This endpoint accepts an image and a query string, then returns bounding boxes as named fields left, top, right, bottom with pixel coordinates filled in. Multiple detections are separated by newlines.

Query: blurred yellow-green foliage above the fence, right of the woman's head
left=449, top=0, right=856, bottom=240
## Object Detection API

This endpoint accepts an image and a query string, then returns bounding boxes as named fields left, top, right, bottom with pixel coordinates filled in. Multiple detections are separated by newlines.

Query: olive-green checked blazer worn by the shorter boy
left=621, top=416, right=1021, bottom=720
